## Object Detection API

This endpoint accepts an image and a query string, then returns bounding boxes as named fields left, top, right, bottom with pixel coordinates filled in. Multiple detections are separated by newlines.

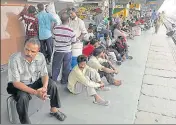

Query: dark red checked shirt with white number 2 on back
left=20, top=8, right=39, bottom=37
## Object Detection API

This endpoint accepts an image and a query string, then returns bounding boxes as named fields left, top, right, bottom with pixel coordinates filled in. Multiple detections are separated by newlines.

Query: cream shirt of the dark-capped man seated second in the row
left=87, top=56, right=105, bottom=71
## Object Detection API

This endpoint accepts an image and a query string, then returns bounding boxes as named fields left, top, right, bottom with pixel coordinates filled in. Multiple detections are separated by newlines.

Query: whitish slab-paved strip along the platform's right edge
left=135, top=27, right=176, bottom=124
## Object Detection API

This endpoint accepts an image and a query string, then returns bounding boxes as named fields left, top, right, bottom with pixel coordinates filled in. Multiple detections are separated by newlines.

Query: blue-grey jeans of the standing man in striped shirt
left=52, top=52, right=72, bottom=84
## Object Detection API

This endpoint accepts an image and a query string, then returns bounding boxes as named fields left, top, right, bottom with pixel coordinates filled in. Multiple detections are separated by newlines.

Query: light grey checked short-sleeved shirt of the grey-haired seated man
left=8, top=52, right=48, bottom=85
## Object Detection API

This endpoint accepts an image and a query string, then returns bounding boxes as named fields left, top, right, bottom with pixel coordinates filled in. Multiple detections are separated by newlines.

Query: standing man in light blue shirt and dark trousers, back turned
left=37, top=3, right=57, bottom=63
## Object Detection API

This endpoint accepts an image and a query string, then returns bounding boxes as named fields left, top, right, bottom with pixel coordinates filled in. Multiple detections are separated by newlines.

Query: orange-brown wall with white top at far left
left=1, top=6, right=25, bottom=65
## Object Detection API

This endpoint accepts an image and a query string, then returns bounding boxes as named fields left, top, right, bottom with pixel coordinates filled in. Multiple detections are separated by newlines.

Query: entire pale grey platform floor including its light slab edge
left=1, top=26, right=176, bottom=124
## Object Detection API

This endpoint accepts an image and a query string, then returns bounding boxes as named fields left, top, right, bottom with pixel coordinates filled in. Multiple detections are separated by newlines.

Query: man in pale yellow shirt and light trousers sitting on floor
left=67, top=55, right=110, bottom=106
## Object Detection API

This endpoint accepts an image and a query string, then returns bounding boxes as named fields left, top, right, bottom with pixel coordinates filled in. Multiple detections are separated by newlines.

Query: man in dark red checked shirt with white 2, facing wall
left=20, top=5, right=39, bottom=40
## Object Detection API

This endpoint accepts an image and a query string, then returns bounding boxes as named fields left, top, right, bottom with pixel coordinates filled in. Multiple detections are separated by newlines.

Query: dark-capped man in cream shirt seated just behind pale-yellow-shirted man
left=87, top=47, right=121, bottom=86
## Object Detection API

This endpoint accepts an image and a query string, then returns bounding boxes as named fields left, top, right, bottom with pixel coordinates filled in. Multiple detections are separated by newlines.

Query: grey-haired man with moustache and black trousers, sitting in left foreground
left=7, top=38, right=66, bottom=124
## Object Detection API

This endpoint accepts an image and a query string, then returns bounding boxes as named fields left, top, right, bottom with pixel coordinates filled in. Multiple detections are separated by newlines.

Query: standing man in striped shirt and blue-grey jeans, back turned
left=52, top=12, right=76, bottom=84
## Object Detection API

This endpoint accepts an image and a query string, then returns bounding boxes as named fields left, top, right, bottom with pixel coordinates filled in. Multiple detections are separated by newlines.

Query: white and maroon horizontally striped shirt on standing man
left=53, top=25, right=76, bottom=53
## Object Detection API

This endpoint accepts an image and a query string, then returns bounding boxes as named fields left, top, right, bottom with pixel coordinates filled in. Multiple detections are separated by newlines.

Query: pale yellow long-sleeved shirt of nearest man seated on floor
left=67, top=65, right=101, bottom=94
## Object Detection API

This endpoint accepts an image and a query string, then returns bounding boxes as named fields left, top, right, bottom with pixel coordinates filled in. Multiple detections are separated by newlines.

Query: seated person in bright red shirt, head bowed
left=83, top=39, right=100, bottom=57
